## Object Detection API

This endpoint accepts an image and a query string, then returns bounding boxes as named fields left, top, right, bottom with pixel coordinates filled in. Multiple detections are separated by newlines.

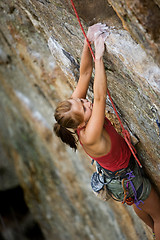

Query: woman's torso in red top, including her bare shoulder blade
left=77, top=118, right=131, bottom=171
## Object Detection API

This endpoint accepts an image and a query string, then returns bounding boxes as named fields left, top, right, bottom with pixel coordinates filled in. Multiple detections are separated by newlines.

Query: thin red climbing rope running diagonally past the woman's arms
left=71, top=0, right=142, bottom=168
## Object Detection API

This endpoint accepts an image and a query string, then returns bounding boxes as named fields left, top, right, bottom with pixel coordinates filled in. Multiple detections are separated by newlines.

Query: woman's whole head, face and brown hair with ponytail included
left=54, top=99, right=92, bottom=150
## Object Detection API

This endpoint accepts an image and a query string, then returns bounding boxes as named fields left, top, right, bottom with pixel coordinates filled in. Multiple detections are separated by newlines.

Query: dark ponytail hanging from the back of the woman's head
left=53, top=123, right=77, bottom=151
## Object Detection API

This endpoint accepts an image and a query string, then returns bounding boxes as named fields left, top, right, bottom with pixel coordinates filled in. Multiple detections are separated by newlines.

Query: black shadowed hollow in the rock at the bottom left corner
left=0, top=186, right=44, bottom=240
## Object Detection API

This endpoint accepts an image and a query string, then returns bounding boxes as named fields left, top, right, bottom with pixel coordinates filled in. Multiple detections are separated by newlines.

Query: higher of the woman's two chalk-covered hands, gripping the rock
left=87, top=23, right=108, bottom=43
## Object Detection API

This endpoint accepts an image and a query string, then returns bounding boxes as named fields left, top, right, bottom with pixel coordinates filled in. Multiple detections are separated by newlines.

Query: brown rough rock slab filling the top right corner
left=109, top=0, right=160, bottom=64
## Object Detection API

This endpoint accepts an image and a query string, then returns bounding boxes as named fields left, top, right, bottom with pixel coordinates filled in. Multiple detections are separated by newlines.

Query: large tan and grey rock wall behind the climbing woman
left=0, top=0, right=160, bottom=240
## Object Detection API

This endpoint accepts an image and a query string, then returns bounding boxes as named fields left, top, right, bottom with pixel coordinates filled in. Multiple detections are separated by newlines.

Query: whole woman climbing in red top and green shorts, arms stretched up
left=54, top=23, right=160, bottom=240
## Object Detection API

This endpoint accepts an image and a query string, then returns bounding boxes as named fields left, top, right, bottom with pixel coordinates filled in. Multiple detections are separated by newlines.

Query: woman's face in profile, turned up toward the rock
left=69, top=98, right=92, bottom=123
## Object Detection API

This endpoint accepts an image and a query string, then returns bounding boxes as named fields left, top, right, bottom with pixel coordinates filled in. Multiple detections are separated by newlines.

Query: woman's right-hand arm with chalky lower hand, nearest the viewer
left=82, top=36, right=107, bottom=144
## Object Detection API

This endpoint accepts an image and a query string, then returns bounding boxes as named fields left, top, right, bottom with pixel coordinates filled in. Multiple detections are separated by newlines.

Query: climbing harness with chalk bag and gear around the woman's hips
left=91, top=157, right=143, bottom=209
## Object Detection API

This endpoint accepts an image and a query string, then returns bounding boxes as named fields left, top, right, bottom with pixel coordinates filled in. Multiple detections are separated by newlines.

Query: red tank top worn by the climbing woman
left=77, top=118, right=131, bottom=172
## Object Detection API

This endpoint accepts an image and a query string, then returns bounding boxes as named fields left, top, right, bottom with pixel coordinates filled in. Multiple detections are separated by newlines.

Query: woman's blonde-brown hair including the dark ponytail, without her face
left=53, top=100, right=83, bottom=151
